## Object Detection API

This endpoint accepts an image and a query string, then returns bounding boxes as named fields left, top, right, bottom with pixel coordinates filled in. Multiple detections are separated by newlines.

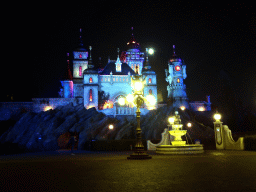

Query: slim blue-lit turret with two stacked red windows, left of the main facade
left=83, top=46, right=99, bottom=109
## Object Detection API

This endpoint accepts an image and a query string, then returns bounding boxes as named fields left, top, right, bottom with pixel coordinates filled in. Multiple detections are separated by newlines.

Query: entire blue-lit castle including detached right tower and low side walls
left=32, top=29, right=211, bottom=116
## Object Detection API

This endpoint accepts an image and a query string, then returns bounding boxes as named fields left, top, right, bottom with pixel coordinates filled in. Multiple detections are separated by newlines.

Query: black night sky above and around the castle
left=1, top=0, right=256, bottom=126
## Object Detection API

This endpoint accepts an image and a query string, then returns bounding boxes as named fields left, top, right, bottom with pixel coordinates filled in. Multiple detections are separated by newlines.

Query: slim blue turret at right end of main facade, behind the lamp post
left=142, top=48, right=157, bottom=107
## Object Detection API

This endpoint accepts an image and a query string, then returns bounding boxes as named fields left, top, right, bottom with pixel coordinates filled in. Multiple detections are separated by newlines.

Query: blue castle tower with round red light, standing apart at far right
left=165, top=45, right=189, bottom=108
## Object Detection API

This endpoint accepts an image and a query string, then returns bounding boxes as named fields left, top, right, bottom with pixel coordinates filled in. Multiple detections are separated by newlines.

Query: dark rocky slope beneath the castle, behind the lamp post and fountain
left=0, top=104, right=214, bottom=151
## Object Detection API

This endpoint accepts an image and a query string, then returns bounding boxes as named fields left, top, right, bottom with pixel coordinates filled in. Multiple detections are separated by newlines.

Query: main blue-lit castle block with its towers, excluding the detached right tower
left=60, top=30, right=157, bottom=115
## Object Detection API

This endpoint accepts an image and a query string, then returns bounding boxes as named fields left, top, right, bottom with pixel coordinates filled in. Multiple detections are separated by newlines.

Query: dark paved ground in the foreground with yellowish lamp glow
left=0, top=150, right=256, bottom=192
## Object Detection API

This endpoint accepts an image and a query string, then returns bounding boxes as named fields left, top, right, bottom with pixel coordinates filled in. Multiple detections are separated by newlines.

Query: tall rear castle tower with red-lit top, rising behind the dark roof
left=125, top=27, right=144, bottom=75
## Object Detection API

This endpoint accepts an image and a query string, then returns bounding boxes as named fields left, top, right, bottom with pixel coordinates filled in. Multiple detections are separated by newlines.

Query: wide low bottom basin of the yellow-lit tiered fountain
left=156, top=144, right=204, bottom=155
